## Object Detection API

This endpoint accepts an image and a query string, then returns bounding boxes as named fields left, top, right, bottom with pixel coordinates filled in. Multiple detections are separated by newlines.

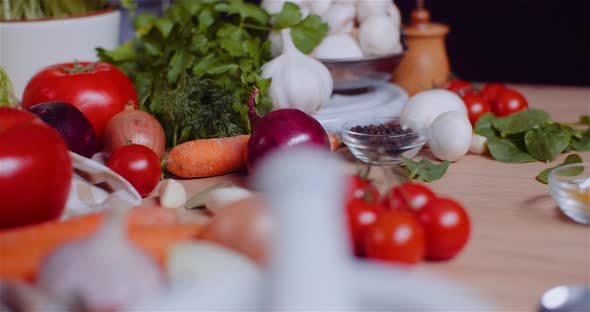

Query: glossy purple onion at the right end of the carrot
left=246, top=108, right=330, bottom=172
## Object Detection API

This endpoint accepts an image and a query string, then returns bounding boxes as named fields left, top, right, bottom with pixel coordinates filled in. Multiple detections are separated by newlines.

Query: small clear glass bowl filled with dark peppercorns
left=342, top=117, right=426, bottom=166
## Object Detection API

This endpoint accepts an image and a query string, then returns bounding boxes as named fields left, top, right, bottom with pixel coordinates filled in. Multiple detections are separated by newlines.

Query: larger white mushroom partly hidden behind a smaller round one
left=400, top=89, right=467, bottom=130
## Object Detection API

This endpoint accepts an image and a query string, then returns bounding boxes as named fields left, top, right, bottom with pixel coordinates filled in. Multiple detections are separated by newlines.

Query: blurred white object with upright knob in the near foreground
left=133, top=147, right=494, bottom=311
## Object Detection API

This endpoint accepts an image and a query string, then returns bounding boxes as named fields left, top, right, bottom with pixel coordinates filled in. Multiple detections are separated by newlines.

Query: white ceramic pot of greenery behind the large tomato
left=0, top=9, right=121, bottom=100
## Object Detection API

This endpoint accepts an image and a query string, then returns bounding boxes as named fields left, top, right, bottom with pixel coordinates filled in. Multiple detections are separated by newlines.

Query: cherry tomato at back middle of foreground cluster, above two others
left=383, top=182, right=436, bottom=210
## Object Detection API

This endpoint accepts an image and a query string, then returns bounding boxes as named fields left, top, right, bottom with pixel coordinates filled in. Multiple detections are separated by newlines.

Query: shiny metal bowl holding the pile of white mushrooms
left=318, top=50, right=405, bottom=92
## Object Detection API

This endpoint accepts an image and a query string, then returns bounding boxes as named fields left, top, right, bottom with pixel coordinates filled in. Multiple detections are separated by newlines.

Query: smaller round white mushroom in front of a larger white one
left=426, top=111, right=473, bottom=161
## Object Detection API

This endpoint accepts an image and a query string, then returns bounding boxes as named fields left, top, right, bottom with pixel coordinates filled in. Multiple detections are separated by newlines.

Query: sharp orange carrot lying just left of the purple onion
left=166, top=135, right=250, bottom=178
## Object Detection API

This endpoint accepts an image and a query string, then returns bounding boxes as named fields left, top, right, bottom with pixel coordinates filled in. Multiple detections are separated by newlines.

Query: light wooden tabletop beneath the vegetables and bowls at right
left=144, top=85, right=590, bottom=311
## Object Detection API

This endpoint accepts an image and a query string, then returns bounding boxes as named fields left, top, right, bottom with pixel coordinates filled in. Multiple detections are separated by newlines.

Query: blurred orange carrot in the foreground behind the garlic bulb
left=0, top=208, right=201, bottom=280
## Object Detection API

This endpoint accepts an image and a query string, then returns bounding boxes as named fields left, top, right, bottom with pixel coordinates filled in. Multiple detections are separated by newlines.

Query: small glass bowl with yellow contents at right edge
left=549, top=163, right=590, bottom=225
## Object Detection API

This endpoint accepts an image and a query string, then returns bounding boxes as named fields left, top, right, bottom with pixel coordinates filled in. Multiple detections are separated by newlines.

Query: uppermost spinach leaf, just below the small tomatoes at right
left=492, top=109, right=551, bottom=137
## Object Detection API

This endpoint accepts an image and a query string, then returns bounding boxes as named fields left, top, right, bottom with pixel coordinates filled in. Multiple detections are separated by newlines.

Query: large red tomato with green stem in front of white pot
left=22, top=62, right=139, bottom=142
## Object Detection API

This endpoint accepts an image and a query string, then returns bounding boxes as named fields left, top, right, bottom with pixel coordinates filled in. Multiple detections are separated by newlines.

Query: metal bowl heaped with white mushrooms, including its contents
left=307, top=0, right=405, bottom=92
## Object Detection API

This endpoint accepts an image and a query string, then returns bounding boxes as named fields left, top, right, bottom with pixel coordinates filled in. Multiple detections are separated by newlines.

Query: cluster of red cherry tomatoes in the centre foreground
left=346, top=176, right=471, bottom=264
